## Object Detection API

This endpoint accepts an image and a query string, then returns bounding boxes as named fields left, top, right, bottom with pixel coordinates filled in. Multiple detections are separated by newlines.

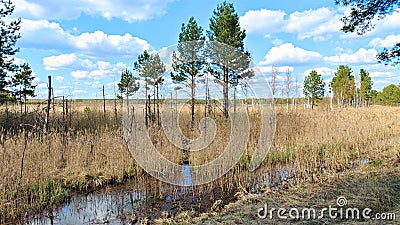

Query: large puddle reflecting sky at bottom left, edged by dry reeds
left=26, top=164, right=203, bottom=225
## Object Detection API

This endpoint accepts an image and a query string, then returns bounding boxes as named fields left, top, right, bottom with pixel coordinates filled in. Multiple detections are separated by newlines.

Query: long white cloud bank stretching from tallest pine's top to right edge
left=240, top=7, right=400, bottom=40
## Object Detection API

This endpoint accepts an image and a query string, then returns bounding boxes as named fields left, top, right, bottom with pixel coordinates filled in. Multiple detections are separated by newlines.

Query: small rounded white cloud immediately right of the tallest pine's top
left=239, top=9, right=286, bottom=35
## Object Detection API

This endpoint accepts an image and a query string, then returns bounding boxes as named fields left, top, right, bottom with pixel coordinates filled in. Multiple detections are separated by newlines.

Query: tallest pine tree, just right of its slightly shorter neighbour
left=207, top=2, right=254, bottom=118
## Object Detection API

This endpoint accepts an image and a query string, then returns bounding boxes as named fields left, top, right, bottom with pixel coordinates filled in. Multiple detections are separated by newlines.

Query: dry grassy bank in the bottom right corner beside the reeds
left=188, top=166, right=400, bottom=224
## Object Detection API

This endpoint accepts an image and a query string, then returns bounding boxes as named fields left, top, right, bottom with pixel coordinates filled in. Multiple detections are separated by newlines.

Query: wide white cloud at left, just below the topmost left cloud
left=19, top=19, right=151, bottom=58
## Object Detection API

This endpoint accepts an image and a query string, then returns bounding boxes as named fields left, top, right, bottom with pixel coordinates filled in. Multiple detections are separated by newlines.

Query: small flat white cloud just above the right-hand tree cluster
left=324, top=48, right=378, bottom=65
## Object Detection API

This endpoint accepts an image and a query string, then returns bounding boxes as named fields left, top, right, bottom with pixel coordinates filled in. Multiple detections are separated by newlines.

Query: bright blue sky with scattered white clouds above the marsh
left=13, top=0, right=400, bottom=98
